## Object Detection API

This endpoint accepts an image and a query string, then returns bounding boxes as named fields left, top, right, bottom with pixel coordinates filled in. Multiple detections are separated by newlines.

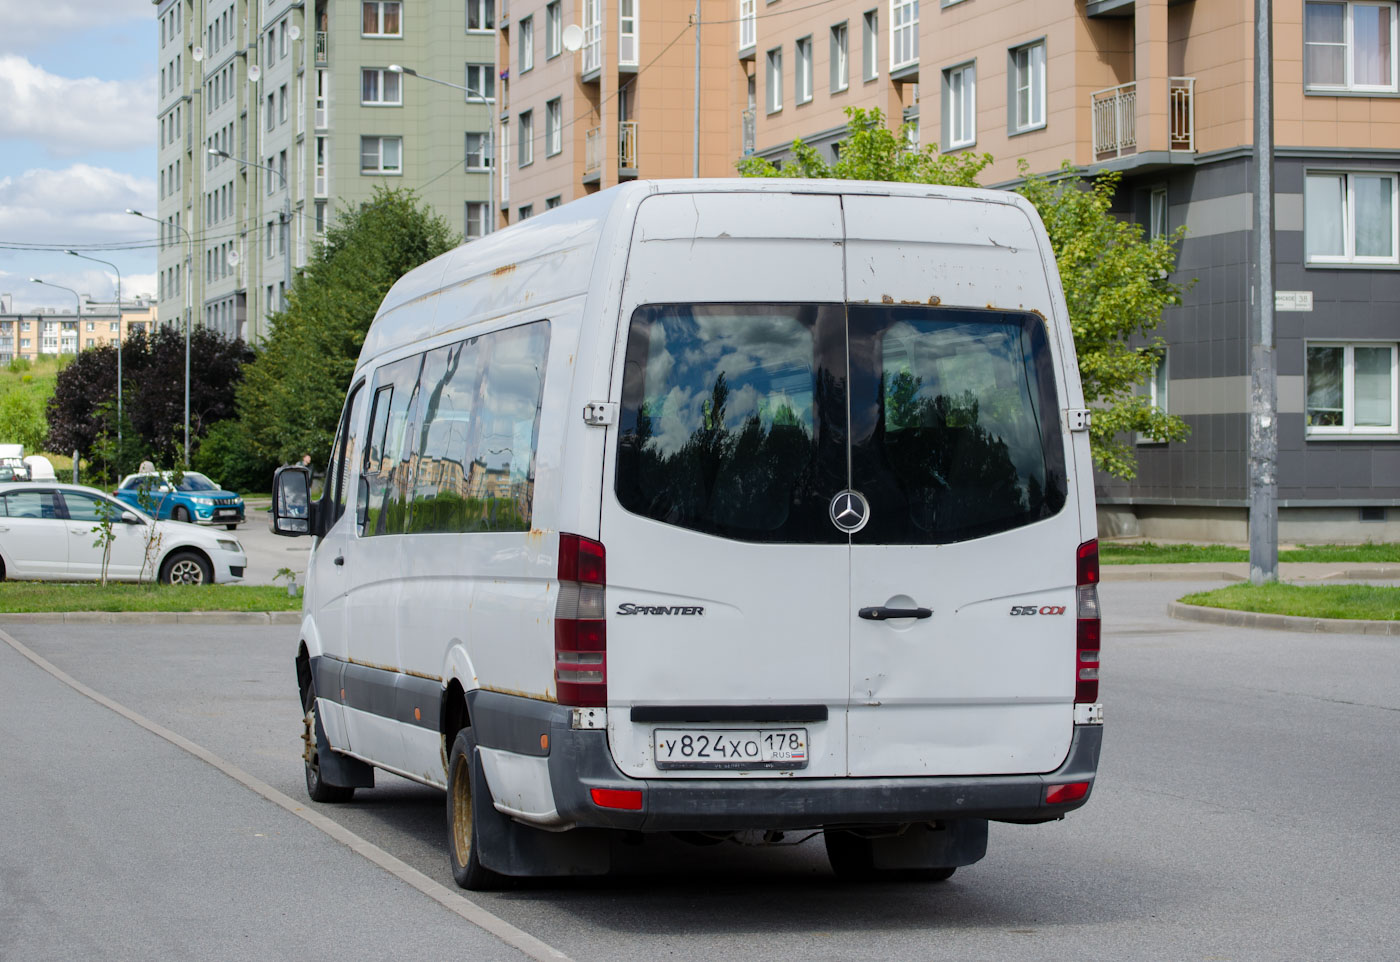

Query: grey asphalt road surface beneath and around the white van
left=0, top=583, right=1400, bottom=962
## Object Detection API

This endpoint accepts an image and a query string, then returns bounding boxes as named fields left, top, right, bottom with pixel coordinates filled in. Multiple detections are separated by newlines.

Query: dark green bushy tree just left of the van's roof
left=238, top=188, right=461, bottom=463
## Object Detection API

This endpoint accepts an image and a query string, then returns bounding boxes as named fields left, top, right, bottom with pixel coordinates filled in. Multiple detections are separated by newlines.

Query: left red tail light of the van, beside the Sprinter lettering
left=554, top=535, right=608, bottom=709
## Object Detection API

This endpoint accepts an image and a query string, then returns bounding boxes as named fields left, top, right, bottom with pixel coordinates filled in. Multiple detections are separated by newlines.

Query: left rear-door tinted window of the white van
left=616, top=304, right=846, bottom=543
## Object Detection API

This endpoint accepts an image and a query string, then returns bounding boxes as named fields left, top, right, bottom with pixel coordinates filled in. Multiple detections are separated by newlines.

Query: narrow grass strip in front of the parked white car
left=0, top=581, right=301, bottom=613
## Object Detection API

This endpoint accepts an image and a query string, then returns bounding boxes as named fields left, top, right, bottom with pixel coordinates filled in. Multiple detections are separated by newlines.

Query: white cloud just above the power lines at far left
left=0, top=164, right=158, bottom=246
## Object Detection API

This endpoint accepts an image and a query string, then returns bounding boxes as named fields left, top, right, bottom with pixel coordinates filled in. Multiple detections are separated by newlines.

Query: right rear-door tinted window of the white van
left=850, top=305, right=1065, bottom=545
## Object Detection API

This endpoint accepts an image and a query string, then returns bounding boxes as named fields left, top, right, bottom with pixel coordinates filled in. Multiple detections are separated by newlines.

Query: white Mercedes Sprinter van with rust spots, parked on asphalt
left=273, top=179, right=1102, bottom=888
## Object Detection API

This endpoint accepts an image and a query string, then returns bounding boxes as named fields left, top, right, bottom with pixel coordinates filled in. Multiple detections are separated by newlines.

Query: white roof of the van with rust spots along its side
left=356, top=178, right=1030, bottom=368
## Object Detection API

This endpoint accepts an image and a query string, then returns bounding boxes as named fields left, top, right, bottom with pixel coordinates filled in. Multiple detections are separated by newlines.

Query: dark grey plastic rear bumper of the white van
left=473, top=699, right=1103, bottom=832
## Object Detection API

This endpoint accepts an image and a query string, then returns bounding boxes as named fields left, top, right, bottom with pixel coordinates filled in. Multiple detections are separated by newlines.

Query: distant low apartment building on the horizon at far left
left=0, top=294, right=155, bottom=364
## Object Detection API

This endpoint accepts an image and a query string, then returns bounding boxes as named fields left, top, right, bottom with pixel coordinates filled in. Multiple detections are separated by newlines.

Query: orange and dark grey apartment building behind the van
left=498, top=0, right=1400, bottom=541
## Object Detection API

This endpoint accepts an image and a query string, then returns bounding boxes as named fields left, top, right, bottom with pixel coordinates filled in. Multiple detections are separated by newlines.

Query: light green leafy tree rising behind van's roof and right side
left=738, top=108, right=1187, bottom=479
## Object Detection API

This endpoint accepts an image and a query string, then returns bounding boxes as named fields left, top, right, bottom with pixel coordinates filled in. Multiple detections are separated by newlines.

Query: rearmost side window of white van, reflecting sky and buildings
left=409, top=321, right=549, bottom=532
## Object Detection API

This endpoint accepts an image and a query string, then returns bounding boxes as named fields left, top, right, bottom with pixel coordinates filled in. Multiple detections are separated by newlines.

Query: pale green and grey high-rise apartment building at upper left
left=153, top=0, right=494, bottom=340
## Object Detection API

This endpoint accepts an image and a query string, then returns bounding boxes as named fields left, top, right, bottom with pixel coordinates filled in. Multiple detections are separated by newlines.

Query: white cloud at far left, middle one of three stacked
left=0, top=56, right=155, bottom=155
